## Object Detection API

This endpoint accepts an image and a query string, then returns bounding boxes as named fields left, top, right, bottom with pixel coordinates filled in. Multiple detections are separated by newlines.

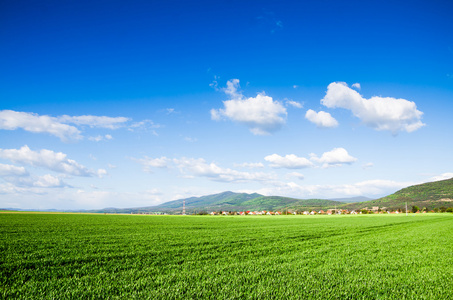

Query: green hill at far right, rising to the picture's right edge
left=342, top=178, right=453, bottom=210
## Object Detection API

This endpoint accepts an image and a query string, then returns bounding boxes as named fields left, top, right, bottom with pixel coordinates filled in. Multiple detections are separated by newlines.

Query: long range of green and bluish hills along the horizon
left=3, top=178, right=453, bottom=214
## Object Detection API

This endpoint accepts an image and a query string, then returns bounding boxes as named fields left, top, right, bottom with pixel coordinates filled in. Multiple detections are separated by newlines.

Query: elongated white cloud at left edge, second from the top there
left=0, top=145, right=102, bottom=177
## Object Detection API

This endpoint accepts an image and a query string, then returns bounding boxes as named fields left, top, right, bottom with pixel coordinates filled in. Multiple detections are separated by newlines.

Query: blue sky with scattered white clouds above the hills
left=0, top=1, right=453, bottom=209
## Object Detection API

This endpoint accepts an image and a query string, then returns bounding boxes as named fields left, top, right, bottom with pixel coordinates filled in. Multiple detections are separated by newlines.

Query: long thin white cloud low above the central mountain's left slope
left=173, top=158, right=273, bottom=182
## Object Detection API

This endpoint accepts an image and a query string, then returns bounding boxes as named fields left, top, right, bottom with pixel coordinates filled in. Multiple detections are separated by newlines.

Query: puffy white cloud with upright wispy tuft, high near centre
left=211, top=79, right=287, bottom=135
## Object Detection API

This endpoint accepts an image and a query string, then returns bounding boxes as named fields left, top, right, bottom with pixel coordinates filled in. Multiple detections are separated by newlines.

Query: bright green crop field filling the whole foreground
left=0, top=213, right=453, bottom=299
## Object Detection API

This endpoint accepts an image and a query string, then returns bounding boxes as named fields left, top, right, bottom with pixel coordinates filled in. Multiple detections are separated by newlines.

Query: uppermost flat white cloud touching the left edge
left=0, top=110, right=82, bottom=140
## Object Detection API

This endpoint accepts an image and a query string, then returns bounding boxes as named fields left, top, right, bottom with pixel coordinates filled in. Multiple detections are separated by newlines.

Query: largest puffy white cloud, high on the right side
left=321, top=82, right=425, bottom=134
